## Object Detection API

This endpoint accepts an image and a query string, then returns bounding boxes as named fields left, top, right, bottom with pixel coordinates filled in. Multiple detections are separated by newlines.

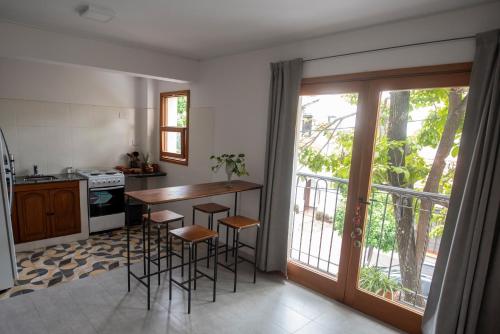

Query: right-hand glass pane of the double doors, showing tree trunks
left=358, top=87, right=468, bottom=311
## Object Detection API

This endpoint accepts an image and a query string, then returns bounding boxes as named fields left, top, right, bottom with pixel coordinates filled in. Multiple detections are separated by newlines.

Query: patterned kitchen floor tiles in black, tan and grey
left=0, top=228, right=176, bottom=299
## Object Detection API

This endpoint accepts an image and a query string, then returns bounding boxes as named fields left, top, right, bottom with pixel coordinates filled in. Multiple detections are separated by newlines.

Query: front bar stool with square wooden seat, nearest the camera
left=168, top=225, right=219, bottom=314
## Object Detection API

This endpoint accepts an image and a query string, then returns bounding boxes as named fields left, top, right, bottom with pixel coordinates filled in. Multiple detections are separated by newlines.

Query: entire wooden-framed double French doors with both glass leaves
left=288, top=64, right=470, bottom=333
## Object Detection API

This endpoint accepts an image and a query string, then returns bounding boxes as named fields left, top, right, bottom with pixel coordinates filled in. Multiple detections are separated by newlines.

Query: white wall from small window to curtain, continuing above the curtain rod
left=191, top=2, right=500, bottom=222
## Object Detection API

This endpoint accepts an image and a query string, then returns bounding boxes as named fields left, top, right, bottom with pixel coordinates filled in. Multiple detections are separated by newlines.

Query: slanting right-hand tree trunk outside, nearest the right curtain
left=416, top=88, right=467, bottom=276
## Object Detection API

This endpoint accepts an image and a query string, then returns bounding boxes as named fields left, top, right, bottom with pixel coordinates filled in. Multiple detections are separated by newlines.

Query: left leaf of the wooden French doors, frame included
left=288, top=83, right=363, bottom=299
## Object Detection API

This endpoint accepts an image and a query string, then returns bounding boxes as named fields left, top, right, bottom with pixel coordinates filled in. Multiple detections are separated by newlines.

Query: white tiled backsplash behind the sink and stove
left=0, top=99, right=137, bottom=175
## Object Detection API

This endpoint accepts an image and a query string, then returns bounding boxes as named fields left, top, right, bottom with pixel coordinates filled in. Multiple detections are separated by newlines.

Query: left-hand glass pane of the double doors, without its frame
left=289, top=93, right=358, bottom=278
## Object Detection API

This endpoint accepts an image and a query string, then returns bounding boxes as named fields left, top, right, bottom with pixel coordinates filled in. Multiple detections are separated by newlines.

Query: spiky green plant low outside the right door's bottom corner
left=359, top=267, right=406, bottom=300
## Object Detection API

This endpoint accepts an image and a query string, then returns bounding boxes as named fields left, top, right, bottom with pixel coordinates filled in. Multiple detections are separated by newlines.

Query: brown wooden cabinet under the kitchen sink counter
left=12, top=182, right=81, bottom=243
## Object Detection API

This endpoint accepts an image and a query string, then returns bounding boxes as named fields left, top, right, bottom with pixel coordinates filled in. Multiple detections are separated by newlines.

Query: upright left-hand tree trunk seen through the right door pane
left=387, top=91, right=420, bottom=303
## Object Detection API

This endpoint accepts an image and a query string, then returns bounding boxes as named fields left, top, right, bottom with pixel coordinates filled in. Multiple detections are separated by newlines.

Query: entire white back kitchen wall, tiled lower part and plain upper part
left=0, top=58, right=186, bottom=175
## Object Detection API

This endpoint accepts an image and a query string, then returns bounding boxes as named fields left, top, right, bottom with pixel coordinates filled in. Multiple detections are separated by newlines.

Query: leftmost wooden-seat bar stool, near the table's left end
left=142, top=210, right=184, bottom=285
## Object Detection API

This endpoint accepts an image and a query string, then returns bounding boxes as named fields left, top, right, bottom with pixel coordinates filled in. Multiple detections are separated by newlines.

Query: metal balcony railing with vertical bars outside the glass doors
left=289, top=173, right=449, bottom=309
